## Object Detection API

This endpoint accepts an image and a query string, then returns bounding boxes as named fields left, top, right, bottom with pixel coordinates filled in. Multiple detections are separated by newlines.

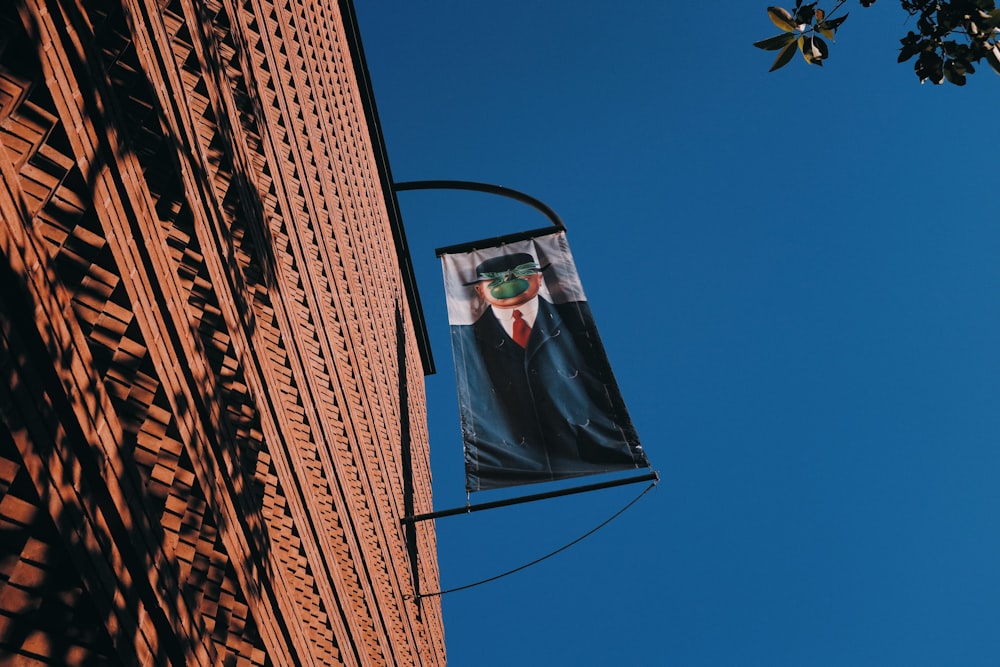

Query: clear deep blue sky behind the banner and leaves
left=357, top=0, right=1000, bottom=667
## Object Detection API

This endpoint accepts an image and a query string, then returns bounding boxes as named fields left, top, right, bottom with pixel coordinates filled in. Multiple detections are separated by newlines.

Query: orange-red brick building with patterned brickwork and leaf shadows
left=0, top=0, right=445, bottom=665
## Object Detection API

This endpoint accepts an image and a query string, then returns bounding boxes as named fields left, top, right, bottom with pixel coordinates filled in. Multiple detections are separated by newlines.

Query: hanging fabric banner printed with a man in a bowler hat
left=438, top=228, right=649, bottom=491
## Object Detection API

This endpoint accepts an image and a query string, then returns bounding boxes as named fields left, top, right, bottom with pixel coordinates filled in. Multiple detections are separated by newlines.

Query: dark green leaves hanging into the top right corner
left=754, top=0, right=1000, bottom=86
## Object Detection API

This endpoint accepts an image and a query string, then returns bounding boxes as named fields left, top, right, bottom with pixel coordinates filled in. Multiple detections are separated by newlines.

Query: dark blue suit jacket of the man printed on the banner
left=451, top=298, right=648, bottom=491
